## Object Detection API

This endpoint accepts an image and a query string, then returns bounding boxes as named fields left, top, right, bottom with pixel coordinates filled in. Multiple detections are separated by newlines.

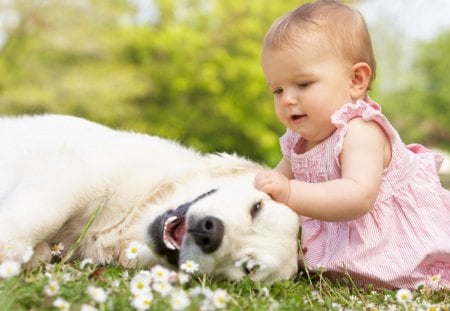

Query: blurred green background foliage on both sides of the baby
left=0, top=0, right=450, bottom=165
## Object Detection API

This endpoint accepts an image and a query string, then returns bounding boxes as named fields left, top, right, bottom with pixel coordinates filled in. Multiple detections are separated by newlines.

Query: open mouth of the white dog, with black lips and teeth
left=148, top=189, right=217, bottom=266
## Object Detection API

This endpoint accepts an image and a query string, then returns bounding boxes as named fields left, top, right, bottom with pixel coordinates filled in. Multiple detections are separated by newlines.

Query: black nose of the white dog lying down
left=188, top=216, right=224, bottom=254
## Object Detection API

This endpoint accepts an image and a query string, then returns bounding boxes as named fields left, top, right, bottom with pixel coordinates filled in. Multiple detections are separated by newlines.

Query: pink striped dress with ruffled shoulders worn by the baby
left=280, top=98, right=450, bottom=288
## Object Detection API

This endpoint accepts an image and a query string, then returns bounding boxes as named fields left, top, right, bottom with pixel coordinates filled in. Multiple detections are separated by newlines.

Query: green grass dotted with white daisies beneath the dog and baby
left=0, top=188, right=450, bottom=311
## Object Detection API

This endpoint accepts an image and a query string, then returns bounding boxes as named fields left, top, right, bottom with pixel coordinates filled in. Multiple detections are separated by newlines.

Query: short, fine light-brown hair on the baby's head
left=264, top=0, right=376, bottom=88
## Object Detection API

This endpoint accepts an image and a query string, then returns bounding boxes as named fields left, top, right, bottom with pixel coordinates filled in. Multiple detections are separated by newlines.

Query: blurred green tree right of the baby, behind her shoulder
left=377, top=32, right=450, bottom=150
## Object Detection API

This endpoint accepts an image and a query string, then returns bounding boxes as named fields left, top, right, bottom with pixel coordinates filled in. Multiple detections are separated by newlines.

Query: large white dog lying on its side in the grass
left=0, top=115, right=299, bottom=282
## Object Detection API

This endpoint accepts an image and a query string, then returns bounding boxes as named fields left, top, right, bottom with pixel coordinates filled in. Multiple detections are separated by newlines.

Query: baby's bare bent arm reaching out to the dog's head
left=255, top=118, right=390, bottom=221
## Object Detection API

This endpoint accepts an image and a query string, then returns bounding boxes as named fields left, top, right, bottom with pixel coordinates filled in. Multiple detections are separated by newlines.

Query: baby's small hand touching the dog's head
left=255, top=170, right=290, bottom=205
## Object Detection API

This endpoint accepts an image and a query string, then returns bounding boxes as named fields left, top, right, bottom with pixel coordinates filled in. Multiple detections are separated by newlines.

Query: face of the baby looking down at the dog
left=262, top=35, right=352, bottom=144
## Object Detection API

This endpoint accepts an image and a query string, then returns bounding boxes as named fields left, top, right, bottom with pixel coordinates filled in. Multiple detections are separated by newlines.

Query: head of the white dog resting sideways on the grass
left=147, top=181, right=300, bottom=282
